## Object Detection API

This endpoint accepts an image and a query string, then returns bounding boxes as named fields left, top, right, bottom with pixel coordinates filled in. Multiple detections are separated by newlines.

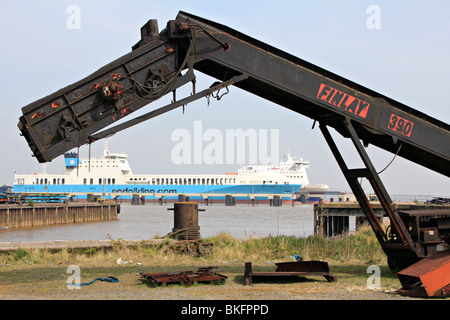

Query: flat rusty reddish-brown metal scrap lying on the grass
left=141, top=267, right=228, bottom=285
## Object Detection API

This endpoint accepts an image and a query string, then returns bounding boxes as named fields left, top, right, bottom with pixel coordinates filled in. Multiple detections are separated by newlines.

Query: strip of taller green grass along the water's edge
left=0, top=227, right=386, bottom=268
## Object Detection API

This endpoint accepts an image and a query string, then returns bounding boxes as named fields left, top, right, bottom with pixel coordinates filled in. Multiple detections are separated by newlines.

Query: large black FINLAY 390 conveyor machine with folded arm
left=18, top=12, right=450, bottom=296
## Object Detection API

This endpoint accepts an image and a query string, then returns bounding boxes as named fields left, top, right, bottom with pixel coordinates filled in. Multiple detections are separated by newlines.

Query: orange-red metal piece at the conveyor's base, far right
left=397, top=250, right=450, bottom=297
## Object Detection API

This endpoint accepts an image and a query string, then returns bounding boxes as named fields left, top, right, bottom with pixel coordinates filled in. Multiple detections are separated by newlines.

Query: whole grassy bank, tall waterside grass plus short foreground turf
left=0, top=227, right=428, bottom=300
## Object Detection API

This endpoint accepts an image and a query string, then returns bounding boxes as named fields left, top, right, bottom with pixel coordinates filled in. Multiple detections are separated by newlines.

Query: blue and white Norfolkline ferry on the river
left=14, top=143, right=329, bottom=200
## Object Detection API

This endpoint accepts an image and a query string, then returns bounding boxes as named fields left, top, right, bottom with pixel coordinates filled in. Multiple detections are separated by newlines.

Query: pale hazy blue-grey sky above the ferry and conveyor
left=0, top=0, right=450, bottom=196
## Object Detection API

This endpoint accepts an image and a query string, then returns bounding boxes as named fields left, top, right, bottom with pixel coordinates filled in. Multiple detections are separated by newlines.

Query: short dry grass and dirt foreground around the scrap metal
left=0, top=263, right=420, bottom=300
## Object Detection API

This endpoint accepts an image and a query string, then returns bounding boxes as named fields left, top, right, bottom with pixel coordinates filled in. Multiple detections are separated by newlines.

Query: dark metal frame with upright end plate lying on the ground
left=244, top=260, right=337, bottom=285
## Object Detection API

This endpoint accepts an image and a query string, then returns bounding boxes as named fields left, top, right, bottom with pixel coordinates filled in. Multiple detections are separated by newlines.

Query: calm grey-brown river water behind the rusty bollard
left=0, top=204, right=354, bottom=242
